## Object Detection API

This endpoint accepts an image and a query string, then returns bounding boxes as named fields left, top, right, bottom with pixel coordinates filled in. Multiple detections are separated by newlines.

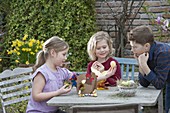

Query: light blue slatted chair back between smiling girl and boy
left=114, top=57, right=138, bottom=80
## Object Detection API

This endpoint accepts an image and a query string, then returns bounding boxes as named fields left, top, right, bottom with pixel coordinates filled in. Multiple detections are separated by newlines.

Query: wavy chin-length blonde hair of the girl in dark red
left=87, top=31, right=113, bottom=61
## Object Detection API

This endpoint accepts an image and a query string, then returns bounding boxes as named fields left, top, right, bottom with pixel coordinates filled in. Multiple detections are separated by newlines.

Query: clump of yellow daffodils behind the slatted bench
left=7, top=35, right=43, bottom=65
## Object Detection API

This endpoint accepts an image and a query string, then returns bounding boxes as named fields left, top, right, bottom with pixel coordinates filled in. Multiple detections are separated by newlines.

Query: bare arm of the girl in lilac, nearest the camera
left=32, top=73, right=71, bottom=102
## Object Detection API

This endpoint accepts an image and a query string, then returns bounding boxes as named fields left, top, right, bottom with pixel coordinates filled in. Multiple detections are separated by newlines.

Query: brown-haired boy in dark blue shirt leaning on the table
left=128, top=26, right=170, bottom=113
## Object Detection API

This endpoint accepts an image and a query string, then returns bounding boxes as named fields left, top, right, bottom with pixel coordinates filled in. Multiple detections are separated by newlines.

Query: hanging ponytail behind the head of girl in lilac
left=33, top=50, right=46, bottom=71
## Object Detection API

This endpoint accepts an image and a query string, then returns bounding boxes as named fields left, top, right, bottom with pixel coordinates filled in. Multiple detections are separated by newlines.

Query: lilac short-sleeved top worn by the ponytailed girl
left=26, top=64, right=72, bottom=113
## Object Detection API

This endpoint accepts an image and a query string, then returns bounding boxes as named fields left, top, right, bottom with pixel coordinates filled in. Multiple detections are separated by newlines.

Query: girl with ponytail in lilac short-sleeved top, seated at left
left=26, top=36, right=72, bottom=113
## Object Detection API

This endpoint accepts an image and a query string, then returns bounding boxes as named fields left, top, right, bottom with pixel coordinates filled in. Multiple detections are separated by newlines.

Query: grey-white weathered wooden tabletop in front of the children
left=47, top=86, right=161, bottom=107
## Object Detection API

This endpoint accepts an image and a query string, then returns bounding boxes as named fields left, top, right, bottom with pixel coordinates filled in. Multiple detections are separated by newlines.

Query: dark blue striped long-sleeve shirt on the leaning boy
left=139, top=42, right=170, bottom=89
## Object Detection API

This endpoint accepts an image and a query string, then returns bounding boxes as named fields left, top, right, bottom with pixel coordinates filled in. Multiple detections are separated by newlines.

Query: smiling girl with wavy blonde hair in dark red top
left=87, top=31, right=121, bottom=86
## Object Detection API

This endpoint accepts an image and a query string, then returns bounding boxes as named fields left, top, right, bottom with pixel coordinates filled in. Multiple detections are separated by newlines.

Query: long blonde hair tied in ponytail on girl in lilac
left=33, top=36, right=69, bottom=71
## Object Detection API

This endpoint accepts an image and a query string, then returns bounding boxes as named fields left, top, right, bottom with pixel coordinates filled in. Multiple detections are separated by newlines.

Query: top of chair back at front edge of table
left=68, top=104, right=139, bottom=113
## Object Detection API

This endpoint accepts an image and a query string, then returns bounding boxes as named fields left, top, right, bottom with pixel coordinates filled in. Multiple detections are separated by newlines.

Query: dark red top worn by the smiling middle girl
left=87, top=57, right=121, bottom=86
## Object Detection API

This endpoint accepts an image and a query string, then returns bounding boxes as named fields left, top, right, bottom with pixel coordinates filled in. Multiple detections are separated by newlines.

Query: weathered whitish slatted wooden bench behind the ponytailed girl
left=0, top=67, right=33, bottom=113
